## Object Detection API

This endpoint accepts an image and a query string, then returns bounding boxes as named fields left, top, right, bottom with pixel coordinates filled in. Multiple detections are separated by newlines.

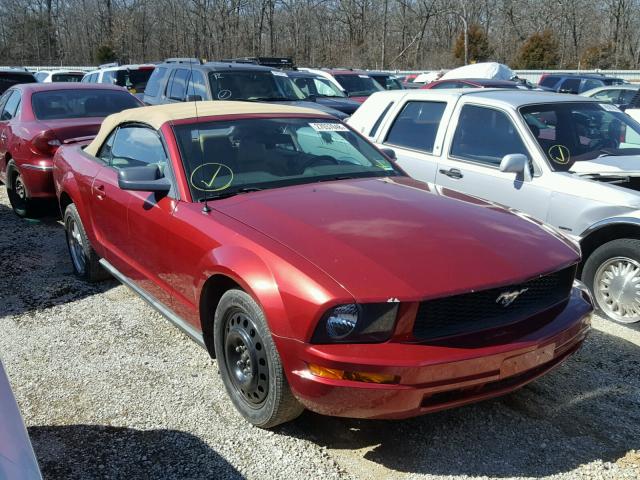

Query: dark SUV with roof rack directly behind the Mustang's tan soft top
left=144, top=58, right=348, bottom=120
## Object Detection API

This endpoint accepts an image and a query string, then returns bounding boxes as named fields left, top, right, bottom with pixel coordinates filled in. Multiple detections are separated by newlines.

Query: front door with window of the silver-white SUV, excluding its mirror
left=436, top=103, right=550, bottom=220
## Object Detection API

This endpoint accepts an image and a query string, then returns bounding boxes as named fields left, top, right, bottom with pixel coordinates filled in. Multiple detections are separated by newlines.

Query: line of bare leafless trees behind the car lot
left=0, top=0, right=640, bottom=70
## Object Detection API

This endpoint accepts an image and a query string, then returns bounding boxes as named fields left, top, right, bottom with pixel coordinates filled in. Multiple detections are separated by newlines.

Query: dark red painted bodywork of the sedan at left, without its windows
left=0, top=83, right=142, bottom=202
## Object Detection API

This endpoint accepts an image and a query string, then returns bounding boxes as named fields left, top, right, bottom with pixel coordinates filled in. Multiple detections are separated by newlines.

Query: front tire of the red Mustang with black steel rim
left=213, top=290, right=304, bottom=428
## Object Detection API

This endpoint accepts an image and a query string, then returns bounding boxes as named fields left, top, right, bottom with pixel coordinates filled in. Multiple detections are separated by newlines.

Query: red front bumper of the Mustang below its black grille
left=275, top=288, right=592, bottom=418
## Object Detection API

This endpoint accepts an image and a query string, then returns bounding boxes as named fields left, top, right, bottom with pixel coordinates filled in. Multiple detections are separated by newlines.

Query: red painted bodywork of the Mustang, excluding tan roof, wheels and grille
left=54, top=111, right=592, bottom=418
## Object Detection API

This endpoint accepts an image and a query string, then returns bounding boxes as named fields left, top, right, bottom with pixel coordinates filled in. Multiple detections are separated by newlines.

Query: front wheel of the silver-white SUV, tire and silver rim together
left=582, top=238, right=640, bottom=323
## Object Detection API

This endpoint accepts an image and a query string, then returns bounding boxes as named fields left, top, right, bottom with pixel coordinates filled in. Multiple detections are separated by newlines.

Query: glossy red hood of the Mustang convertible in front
left=212, top=177, right=578, bottom=302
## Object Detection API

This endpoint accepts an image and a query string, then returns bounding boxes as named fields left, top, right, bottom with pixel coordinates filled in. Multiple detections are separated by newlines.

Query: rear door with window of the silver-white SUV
left=374, top=99, right=453, bottom=183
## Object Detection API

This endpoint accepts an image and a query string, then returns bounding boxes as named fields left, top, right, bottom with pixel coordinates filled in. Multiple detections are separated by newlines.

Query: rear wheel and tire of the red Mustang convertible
left=63, top=203, right=109, bottom=283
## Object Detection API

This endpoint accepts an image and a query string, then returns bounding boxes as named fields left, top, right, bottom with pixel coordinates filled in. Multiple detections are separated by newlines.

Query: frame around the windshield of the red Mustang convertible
left=170, top=113, right=407, bottom=203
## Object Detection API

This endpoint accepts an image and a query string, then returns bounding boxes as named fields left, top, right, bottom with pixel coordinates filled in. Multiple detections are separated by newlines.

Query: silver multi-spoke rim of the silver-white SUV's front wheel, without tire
left=593, top=257, right=640, bottom=323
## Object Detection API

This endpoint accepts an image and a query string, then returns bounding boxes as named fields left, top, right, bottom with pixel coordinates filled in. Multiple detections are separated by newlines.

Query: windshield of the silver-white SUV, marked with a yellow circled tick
left=520, top=102, right=640, bottom=170
